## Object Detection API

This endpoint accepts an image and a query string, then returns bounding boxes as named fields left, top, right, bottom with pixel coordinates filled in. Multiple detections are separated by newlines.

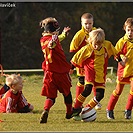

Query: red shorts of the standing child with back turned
left=41, top=71, right=72, bottom=98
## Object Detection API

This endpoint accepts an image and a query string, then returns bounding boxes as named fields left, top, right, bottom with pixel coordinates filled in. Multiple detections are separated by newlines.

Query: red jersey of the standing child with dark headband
left=40, top=34, right=71, bottom=73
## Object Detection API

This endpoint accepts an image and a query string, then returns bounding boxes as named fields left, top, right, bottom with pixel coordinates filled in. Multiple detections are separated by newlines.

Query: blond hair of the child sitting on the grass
left=6, top=74, right=23, bottom=87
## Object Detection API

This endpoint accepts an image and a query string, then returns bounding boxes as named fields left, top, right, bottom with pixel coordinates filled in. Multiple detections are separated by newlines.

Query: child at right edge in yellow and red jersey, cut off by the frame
left=107, top=18, right=133, bottom=119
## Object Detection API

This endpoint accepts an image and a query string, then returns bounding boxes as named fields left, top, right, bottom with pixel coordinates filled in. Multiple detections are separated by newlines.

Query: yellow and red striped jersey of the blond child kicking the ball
left=71, top=40, right=118, bottom=83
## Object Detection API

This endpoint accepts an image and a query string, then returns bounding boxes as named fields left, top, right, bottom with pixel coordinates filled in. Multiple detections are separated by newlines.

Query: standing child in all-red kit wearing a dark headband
left=40, top=17, right=72, bottom=123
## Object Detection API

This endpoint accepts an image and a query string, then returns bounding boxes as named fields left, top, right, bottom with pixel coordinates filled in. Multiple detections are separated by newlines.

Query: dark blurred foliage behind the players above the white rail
left=0, top=2, right=133, bottom=69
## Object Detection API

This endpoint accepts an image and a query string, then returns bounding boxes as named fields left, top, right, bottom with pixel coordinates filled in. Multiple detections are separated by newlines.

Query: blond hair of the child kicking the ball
left=87, top=28, right=105, bottom=43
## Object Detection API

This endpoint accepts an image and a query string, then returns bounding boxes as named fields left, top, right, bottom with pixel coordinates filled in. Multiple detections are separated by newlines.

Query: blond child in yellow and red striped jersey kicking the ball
left=71, top=28, right=122, bottom=116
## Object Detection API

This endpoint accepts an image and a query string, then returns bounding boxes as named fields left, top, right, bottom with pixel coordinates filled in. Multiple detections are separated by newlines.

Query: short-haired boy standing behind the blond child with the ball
left=70, top=13, right=102, bottom=116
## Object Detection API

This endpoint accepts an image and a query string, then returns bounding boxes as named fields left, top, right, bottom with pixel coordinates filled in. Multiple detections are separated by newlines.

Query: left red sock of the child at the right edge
left=107, top=94, right=119, bottom=110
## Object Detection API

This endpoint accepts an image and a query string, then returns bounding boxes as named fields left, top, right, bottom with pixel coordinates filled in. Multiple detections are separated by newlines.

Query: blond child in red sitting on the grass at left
left=0, top=74, right=33, bottom=113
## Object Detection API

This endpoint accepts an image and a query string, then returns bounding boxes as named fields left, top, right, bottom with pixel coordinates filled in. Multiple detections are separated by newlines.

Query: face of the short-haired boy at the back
left=81, top=18, right=93, bottom=32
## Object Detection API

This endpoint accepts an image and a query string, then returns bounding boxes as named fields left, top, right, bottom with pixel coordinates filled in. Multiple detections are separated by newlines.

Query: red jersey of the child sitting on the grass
left=0, top=89, right=28, bottom=113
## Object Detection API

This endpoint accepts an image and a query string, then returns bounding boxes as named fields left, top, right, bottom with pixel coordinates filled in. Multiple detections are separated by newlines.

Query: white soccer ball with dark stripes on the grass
left=80, top=107, right=97, bottom=122
